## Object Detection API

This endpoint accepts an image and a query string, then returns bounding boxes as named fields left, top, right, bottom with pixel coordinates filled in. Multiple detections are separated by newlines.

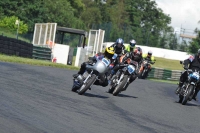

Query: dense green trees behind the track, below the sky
left=0, top=0, right=199, bottom=51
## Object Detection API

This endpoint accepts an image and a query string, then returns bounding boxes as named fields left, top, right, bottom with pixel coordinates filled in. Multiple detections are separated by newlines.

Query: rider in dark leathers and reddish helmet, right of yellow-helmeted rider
left=110, top=47, right=142, bottom=83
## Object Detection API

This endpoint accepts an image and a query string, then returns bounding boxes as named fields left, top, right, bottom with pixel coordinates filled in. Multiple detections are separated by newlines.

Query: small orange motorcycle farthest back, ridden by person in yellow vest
left=138, top=60, right=155, bottom=79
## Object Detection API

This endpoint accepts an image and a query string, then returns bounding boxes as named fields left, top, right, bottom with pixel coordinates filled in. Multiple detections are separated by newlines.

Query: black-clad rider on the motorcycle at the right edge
left=176, top=49, right=200, bottom=101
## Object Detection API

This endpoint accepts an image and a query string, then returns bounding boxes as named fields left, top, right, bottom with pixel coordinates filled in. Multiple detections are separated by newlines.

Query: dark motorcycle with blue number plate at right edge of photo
left=176, top=61, right=200, bottom=105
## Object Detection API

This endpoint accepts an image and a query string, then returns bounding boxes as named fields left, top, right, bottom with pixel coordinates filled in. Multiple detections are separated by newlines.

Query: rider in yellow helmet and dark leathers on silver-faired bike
left=73, top=47, right=114, bottom=87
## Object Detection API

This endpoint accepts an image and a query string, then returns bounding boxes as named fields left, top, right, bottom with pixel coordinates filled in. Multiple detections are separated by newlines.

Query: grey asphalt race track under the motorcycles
left=0, top=62, right=200, bottom=133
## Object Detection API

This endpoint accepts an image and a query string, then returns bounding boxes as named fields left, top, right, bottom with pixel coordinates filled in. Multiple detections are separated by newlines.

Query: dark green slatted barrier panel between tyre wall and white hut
left=32, top=45, right=52, bottom=61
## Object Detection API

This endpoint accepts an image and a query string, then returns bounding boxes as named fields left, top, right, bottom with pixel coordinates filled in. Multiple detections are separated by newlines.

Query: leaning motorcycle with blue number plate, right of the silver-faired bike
left=108, top=60, right=138, bottom=96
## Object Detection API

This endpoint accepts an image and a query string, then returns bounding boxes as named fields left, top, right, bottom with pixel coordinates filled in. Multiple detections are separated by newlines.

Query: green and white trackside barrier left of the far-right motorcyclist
left=148, top=68, right=182, bottom=81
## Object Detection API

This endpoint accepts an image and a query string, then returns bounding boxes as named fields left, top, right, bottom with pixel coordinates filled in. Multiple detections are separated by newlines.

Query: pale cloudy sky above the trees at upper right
left=155, top=0, right=200, bottom=32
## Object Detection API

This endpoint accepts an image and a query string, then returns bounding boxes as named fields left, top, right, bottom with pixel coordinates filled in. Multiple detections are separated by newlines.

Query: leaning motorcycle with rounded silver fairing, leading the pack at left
left=72, top=58, right=110, bottom=95
